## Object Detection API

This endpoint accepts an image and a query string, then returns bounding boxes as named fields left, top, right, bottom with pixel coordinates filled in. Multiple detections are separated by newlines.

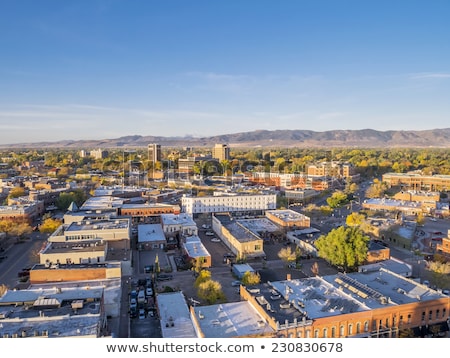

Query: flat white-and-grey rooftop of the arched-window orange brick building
left=247, top=268, right=448, bottom=325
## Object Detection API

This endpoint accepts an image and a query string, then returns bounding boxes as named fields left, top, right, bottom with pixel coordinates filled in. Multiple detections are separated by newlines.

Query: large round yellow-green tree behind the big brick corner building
left=315, top=226, right=369, bottom=270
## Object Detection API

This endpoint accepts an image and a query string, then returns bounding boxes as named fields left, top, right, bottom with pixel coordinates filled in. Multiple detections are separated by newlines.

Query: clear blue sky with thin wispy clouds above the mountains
left=0, top=0, right=450, bottom=144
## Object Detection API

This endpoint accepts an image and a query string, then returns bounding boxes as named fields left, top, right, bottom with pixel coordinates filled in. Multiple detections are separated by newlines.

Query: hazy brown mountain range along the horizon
left=0, top=128, right=450, bottom=149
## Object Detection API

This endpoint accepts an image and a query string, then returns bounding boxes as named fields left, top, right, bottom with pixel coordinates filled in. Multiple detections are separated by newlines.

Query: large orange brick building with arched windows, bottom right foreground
left=241, top=268, right=450, bottom=338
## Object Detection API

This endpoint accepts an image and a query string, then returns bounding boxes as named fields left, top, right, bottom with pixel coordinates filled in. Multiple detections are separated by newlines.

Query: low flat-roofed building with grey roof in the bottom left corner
left=0, top=284, right=107, bottom=338
